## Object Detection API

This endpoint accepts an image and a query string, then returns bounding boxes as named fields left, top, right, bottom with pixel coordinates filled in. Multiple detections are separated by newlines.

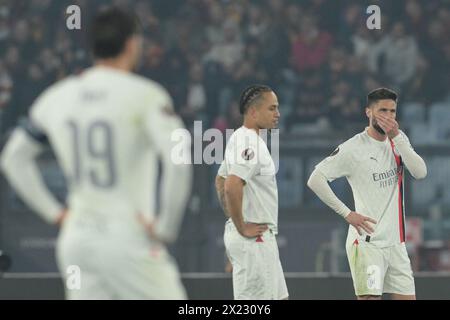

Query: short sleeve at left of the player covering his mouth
left=316, top=144, right=351, bottom=182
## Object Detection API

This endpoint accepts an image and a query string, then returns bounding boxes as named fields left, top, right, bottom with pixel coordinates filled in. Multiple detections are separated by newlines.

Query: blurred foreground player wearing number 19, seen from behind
left=1, top=8, right=192, bottom=299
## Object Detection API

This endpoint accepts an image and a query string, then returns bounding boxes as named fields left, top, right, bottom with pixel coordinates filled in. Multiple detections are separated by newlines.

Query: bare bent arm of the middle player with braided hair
left=224, top=175, right=268, bottom=238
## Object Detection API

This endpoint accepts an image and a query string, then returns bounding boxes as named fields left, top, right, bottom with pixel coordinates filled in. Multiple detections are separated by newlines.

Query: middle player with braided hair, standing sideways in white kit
left=216, top=85, right=288, bottom=300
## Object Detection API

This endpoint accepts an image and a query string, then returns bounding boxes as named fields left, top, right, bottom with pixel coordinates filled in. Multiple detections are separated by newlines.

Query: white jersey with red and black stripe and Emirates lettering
left=316, top=130, right=412, bottom=247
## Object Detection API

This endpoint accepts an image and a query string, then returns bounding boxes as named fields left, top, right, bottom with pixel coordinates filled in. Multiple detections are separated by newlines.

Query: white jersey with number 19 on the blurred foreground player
left=25, top=66, right=188, bottom=241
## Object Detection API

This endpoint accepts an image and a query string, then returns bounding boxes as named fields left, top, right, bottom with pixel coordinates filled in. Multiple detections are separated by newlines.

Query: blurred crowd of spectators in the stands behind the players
left=0, top=0, right=450, bottom=138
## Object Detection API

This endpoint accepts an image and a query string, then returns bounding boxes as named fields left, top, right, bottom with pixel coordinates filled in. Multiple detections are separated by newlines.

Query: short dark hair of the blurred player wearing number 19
left=88, top=7, right=141, bottom=58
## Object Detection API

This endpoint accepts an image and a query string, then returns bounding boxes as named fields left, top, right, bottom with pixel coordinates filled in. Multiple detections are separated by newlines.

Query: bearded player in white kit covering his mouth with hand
left=308, top=88, right=427, bottom=300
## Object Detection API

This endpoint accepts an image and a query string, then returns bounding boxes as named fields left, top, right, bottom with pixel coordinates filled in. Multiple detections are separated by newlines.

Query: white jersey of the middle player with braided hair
left=218, top=126, right=278, bottom=234
